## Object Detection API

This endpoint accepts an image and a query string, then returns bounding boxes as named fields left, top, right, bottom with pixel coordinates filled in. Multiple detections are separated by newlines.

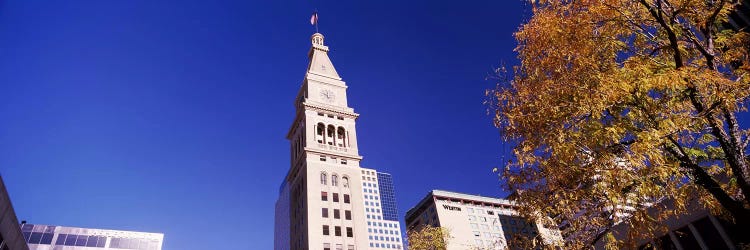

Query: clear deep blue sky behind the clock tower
left=0, top=0, right=528, bottom=250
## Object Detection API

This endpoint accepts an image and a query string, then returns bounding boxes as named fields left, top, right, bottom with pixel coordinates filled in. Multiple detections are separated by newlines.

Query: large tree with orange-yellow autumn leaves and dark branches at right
left=490, top=0, right=750, bottom=247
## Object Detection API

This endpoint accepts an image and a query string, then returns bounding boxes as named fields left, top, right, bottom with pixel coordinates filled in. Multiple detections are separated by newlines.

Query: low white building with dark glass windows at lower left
left=21, top=224, right=164, bottom=250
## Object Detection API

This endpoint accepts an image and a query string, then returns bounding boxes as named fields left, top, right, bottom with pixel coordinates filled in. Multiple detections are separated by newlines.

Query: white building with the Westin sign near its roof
left=406, top=190, right=562, bottom=250
